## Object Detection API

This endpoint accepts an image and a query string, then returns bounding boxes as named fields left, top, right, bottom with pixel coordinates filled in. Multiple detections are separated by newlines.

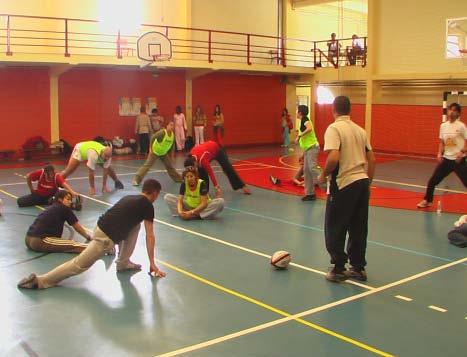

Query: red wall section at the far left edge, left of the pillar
left=0, top=68, right=50, bottom=150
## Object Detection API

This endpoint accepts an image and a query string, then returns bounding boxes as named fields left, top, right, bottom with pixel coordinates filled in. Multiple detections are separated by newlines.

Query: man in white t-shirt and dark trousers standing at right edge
left=417, top=103, right=467, bottom=208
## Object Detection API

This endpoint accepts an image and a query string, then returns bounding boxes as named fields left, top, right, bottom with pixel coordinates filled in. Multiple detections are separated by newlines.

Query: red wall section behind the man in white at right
left=371, top=104, right=442, bottom=156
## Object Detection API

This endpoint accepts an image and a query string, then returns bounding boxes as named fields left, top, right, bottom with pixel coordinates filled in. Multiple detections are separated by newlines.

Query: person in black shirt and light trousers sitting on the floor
left=25, top=190, right=91, bottom=253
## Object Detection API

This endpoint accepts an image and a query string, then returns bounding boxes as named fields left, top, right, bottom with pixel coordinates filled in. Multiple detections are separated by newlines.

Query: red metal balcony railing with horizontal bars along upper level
left=0, top=14, right=367, bottom=68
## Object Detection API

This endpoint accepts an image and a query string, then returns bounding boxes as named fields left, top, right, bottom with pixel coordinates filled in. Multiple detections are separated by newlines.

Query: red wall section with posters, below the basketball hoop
left=59, top=69, right=186, bottom=144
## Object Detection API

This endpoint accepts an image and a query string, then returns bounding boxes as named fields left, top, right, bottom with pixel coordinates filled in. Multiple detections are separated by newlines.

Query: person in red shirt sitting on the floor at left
left=17, top=165, right=79, bottom=207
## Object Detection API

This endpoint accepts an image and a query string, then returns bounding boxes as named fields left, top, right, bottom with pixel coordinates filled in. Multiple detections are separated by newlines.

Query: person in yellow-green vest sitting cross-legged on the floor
left=164, top=166, right=224, bottom=220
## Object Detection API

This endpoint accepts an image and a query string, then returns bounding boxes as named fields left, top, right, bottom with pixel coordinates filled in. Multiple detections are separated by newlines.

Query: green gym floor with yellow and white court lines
left=0, top=148, right=467, bottom=357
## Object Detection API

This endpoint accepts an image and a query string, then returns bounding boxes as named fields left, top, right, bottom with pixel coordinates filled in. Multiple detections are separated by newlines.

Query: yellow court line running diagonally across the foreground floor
left=157, top=259, right=392, bottom=356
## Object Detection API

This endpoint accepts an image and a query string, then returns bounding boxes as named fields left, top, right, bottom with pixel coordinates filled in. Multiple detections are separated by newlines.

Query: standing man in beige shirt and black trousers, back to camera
left=319, top=96, right=375, bottom=282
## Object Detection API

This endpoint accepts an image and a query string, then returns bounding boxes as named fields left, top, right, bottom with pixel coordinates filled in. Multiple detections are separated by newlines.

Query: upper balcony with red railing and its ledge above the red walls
left=0, top=14, right=367, bottom=74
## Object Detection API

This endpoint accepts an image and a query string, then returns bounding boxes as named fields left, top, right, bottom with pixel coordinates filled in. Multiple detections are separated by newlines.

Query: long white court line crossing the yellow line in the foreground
left=157, top=257, right=467, bottom=357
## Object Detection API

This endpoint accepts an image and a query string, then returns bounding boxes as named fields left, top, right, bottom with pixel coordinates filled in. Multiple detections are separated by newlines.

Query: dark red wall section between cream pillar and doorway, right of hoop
left=192, top=73, right=286, bottom=146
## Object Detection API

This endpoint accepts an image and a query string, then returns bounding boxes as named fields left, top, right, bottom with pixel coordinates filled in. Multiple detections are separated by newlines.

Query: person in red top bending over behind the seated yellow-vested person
left=184, top=141, right=251, bottom=198
